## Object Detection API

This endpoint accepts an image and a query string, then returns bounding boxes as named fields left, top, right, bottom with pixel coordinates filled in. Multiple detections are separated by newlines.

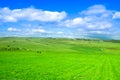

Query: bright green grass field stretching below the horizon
left=0, top=38, right=120, bottom=80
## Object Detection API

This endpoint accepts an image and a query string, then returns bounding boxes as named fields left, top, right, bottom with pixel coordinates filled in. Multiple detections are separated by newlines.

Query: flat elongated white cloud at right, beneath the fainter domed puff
left=62, top=17, right=112, bottom=29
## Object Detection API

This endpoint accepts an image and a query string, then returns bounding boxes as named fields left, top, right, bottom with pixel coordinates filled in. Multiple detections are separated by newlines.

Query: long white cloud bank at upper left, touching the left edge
left=0, top=7, right=67, bottom=22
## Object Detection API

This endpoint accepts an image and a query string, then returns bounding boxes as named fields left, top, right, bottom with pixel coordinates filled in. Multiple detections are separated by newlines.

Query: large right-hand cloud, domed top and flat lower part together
left=62, top=5, right=113, bottom=29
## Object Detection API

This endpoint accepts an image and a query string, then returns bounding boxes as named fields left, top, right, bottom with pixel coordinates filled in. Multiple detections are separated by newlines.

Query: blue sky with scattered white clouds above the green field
left=0, top=0, right=120, bottom=39
